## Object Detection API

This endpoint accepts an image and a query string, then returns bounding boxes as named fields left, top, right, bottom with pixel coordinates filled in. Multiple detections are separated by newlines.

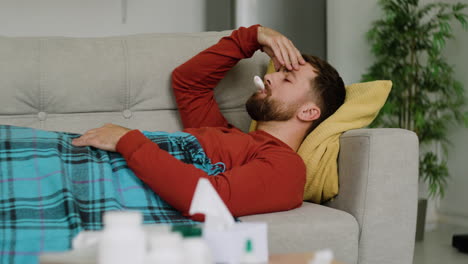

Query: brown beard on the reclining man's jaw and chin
left=245, top=93, right=298, bottom=121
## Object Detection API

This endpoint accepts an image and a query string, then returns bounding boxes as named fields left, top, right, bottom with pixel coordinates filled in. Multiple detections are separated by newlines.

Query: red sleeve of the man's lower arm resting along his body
left=117, top=130, right=305, bottom=220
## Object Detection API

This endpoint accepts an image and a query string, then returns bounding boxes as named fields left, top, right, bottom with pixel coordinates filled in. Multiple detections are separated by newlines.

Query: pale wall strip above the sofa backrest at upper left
left=0, top=0, right=205, bottom=37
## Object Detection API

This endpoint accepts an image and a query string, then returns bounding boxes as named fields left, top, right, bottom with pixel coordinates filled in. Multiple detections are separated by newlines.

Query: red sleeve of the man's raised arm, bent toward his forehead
left=172, top=25, right=261, bottom=128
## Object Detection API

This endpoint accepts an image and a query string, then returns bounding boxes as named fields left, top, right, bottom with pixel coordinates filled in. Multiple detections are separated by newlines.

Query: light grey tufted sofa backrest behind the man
left=0, top=31, right=268, bottom=133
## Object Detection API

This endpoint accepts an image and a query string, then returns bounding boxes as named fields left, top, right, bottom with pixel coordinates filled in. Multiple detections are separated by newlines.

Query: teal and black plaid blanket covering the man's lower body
left=0, top=125, right=224, bottom=264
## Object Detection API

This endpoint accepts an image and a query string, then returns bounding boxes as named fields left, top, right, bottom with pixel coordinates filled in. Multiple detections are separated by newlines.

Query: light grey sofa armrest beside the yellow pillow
left=326, top=128, right=419, bottom=264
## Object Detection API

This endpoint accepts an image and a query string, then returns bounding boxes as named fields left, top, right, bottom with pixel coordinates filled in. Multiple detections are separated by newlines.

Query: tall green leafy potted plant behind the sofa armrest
left=362, top=0, right=468, bottom=240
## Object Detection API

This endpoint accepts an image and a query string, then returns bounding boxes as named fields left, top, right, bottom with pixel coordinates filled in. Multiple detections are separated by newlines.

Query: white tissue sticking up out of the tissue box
left=189, top=178, right=234, bottom=231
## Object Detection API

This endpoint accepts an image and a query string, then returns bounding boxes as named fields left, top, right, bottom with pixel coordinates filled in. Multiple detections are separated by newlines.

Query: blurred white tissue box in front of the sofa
left=203, top=222, right=268, bottom=264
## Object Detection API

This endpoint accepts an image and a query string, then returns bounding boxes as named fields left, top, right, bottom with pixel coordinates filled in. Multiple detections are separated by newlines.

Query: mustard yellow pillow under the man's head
left=250, top=60, right=392, bottom=203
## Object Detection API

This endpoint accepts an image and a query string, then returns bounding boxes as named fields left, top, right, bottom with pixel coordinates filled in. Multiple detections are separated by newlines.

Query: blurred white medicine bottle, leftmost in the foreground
left=98, top=211, right=146, bottom=264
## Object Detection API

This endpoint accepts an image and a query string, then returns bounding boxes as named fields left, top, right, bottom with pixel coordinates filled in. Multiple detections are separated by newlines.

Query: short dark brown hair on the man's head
left=302, top=54, right=346, bottom=134
